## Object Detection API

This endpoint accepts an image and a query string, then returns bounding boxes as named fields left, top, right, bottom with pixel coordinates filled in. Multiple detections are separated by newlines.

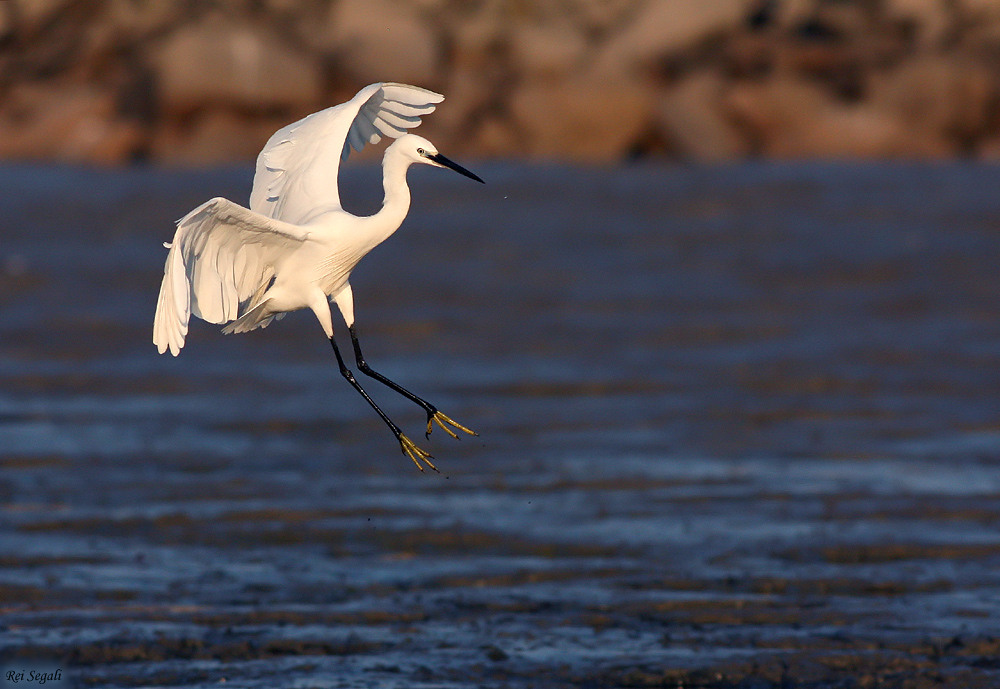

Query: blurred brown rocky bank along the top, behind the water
left=0, top=0, right=1000, bottom=164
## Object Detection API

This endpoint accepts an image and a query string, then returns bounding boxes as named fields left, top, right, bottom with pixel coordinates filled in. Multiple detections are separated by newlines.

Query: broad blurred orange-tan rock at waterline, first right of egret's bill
left=510, top=75, right=652, bottom=162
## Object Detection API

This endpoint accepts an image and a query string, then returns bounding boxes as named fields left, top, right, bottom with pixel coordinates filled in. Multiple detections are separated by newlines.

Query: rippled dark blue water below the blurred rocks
left=0, top=163, right=1000, bottom=688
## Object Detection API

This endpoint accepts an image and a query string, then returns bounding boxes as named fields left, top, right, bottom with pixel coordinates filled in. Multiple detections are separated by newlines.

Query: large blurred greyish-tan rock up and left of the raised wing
left=153, top=14, right=322, bottom=115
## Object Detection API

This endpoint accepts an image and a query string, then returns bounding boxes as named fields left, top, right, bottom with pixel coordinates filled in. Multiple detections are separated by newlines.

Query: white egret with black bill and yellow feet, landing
left=153, top=83, right=483, bottom=471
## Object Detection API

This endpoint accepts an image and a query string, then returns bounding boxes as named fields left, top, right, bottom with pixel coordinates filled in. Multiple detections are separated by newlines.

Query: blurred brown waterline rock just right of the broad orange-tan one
left=656, top=71, right=750, bottom=162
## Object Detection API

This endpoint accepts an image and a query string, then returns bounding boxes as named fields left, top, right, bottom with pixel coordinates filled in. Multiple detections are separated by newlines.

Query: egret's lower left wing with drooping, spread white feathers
left=153, top=198, right=309, bottom=356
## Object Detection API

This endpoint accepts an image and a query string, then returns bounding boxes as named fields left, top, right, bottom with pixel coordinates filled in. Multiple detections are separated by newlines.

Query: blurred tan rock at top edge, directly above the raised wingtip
left=328, top=0, right=444, bottom=88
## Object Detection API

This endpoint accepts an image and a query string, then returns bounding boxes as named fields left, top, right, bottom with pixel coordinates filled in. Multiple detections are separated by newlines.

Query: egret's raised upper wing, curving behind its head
left=250, top=83, right=444, bottom=224
